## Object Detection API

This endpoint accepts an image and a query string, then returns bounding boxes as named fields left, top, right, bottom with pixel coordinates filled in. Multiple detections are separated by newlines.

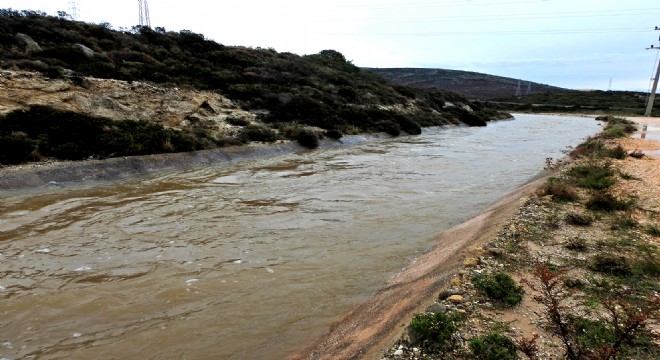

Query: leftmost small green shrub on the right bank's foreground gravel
left=409, top=312, right=462, bottom=350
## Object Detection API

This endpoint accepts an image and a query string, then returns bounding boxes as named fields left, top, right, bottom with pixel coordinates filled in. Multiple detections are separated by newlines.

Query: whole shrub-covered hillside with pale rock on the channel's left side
left=0, top=9, right=508, bottom=164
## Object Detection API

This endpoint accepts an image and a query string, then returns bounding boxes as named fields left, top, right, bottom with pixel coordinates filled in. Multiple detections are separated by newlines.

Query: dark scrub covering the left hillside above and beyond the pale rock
left=0, top=9, right=510, bottom=165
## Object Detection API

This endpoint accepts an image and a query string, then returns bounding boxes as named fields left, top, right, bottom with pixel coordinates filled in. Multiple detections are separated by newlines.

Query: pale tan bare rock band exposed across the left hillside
left=0, top=70, right=256, bottom=136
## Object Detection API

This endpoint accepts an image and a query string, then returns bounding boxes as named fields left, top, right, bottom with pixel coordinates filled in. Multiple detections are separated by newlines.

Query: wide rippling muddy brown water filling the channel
left=0, top=115, right=599, bottom=359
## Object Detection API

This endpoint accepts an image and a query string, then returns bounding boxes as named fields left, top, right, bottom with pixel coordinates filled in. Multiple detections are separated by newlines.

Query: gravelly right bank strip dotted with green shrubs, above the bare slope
left=371, top=118, right=660, bottom=359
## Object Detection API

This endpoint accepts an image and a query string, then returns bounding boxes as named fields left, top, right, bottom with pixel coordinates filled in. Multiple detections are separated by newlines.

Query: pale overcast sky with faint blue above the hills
left=0, top=0, right=660, bottom=91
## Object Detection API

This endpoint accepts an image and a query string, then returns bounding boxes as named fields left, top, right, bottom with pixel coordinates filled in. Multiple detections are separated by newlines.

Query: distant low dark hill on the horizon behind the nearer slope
left=365, top=68, right=567, bottom=99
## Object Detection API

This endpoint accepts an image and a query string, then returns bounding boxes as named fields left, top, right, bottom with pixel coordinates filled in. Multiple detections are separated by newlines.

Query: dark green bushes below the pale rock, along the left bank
left=0, top=105, right=219, bottom=164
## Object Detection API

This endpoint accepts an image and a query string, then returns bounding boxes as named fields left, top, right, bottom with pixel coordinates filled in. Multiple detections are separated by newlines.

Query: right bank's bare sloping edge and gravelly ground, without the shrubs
left=297, top=118, right=660, bottom=359
